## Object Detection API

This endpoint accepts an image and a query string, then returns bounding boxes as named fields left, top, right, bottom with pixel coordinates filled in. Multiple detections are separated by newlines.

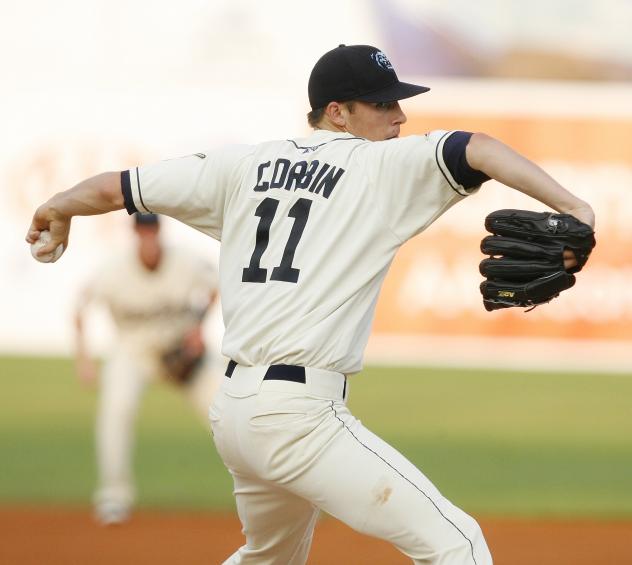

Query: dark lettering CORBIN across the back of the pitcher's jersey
left=253, top=159, right=345, bottom=198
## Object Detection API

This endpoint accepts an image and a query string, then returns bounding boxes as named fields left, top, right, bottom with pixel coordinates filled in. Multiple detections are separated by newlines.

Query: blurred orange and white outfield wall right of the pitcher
left=370, top=81, right=632, bottom=371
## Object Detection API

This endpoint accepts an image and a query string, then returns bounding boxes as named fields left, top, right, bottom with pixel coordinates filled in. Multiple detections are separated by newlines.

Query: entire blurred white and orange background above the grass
left=0, top=0, right=632, bottom=370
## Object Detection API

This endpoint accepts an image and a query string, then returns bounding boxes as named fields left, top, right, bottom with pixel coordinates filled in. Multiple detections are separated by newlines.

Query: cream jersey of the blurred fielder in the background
left=88, top=246, right=217, bottom=355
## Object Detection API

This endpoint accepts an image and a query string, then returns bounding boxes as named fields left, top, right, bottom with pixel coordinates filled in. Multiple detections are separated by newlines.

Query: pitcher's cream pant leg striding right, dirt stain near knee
left=211, top=382, right=492, bottom=565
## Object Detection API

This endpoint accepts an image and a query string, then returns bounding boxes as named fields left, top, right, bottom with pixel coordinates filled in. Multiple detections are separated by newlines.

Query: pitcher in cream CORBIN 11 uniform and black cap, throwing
left=27, top=45, right=594, bottom=565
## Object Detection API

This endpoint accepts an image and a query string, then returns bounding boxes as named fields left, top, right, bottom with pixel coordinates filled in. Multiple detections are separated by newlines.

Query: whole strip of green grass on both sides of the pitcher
left=0, top=358, right=632, bottom=517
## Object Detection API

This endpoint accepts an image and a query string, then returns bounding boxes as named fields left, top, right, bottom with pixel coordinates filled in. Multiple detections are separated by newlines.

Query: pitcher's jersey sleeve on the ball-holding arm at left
left=121, top=145, right=252, bottom=240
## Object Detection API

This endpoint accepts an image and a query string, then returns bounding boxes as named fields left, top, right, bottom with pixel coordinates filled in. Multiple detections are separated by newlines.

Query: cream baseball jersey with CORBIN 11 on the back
left=122, top=130, right=472, bottom=374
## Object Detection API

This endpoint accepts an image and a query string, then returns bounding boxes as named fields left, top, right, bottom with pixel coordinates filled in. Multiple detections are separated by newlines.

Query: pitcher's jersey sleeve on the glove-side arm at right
left=364, top=130, right=479, bottom=242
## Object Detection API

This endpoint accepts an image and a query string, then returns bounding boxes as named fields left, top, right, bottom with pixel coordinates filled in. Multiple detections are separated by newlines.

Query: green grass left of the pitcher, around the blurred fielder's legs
left=0, top=358, right=233, bottom=508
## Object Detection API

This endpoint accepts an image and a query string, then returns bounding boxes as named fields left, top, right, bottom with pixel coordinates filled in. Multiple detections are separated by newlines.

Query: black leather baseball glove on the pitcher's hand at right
left=480, top=209, right=595, bottom=311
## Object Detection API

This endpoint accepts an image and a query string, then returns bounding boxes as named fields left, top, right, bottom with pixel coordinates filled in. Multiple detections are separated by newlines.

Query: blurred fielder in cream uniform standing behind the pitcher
left=76, top=214, right=221, bottom=524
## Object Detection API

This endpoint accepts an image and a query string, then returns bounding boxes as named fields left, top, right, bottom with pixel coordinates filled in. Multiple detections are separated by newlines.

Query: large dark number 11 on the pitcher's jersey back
left=241, top=198, right=312, bottom=283
